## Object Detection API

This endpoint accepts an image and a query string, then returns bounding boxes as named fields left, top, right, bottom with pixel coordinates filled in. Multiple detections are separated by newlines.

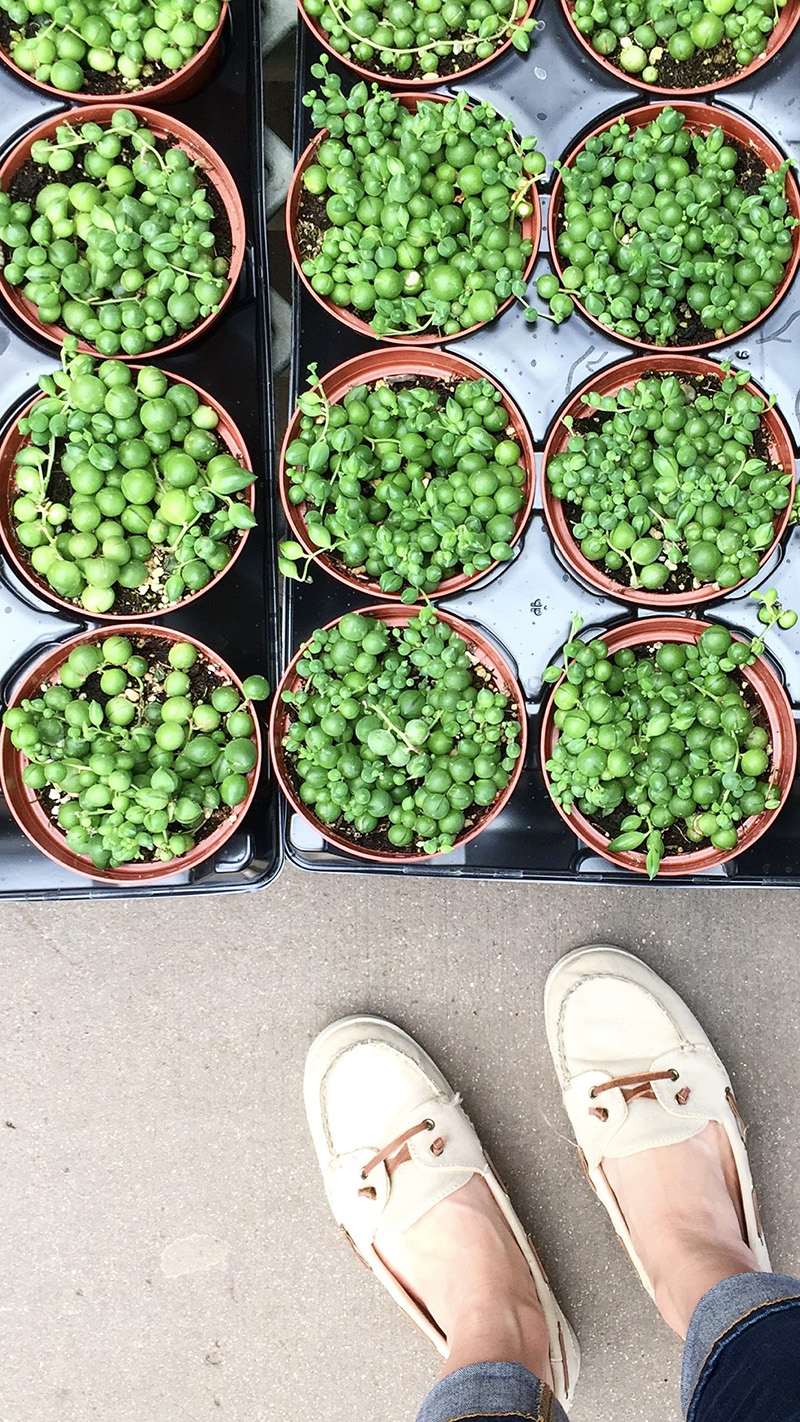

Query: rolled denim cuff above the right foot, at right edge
left=681, top=1274, right=800, bottom=1416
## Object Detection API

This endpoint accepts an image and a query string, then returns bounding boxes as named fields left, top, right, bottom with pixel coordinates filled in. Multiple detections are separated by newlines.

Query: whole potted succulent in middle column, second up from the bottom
left=279, top=350, right=536, bottom=602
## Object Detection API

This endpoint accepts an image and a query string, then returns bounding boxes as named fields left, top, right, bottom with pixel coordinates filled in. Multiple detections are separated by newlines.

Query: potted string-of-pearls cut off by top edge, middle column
left=297, top=0, right=536, bottom=85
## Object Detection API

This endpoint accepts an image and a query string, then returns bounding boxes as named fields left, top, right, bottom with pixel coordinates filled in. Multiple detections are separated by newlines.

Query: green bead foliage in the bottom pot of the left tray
left=3, top=636, right=270, bottom=869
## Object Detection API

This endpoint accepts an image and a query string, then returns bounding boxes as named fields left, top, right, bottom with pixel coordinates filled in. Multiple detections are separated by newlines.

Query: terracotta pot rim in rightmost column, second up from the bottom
left=541, top=350, right=796, bottom=607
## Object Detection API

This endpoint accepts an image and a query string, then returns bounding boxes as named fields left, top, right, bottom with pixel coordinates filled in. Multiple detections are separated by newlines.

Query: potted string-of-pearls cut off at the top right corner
left=561, top=0, right=800, bottom=98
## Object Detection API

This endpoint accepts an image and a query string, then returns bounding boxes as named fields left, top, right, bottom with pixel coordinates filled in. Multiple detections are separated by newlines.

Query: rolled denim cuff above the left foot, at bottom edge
left=416, top=1362, right=567, bottom=1422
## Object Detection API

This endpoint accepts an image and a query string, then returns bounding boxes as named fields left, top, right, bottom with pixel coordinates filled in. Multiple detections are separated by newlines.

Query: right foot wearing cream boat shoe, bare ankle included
left=544, top=944, right=769, bottom=1337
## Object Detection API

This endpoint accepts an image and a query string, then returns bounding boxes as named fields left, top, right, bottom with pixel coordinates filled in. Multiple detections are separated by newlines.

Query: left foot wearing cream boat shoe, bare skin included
left=304, top=1017, right=580, bottom=1406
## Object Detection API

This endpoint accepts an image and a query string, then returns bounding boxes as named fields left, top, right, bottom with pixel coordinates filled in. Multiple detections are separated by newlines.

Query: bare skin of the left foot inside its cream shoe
left=375, top=1165, right=553, bottom=1386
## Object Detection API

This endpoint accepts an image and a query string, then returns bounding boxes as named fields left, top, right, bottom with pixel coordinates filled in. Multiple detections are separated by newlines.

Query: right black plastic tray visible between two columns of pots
left=284, top=8, right=800, bottom=886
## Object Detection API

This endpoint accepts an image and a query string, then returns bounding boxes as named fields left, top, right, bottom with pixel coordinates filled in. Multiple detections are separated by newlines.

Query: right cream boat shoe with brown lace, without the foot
left=544, top=943, right=770, bottom=1298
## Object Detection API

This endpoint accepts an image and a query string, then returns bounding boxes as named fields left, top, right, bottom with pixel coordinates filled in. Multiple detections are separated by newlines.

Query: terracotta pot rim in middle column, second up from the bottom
left=278, top=350, right=536, bottom=597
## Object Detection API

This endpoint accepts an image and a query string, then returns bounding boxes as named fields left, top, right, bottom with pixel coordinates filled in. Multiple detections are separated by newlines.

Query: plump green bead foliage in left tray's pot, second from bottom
left=11, top=337, right=256, bottom=613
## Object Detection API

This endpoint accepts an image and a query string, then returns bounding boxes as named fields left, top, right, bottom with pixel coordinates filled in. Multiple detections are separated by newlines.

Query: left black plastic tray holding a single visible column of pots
left=0, top=0, right=283, bottom=899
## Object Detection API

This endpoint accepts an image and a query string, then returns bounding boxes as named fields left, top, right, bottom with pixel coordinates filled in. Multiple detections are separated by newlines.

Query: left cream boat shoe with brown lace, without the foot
left=304, top=1017, right=580, bottom=1406
